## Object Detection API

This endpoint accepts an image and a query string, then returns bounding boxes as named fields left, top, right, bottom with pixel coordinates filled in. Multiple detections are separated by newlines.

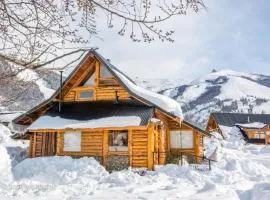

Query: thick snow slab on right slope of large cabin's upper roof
left=113, top=69, right=183, bottom=119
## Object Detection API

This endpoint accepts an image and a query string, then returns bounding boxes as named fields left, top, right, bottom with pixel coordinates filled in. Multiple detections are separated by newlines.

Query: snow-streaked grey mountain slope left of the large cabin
left=0, top=60, right=59, bottom=112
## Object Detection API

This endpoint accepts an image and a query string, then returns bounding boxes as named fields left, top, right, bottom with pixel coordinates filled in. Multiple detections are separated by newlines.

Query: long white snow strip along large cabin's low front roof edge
left=28, top=116, right=141, bottom=130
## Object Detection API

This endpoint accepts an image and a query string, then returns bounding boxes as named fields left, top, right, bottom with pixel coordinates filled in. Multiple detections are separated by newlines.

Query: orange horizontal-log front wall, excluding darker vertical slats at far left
left=51, top=127, right=150, bottom=168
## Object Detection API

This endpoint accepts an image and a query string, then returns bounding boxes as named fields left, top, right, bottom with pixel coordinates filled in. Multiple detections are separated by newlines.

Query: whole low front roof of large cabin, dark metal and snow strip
left=28, top=101, right=154, bottom=130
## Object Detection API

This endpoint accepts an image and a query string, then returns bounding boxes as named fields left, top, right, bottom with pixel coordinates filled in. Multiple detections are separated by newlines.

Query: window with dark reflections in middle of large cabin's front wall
left=109, top=131, right=128, bottom=151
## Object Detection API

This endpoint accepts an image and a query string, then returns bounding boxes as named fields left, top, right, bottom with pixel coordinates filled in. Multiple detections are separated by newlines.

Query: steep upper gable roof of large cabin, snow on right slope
left=13, top=50, right=182, bottom=125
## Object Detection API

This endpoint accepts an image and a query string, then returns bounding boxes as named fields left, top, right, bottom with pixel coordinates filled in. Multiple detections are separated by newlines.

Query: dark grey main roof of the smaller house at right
left=212, top=113, right=270, bottom=127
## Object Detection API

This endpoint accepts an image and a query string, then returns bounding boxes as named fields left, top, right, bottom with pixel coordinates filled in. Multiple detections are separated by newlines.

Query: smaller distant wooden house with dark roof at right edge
left=206, top=113, right=270, bottom=144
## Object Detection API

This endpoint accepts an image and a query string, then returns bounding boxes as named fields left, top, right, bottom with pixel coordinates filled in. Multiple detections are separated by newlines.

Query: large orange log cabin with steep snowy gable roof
left=13, top=50, right=209, bottom=169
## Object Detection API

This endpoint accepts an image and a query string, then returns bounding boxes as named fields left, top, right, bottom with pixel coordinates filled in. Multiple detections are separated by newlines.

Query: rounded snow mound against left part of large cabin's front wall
left=13, top=156, right=108, bottom=185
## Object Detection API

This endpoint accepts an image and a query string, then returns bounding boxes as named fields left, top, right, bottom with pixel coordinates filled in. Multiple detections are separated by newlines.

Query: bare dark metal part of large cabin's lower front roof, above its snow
left=39, top=102, right=154, bottom=126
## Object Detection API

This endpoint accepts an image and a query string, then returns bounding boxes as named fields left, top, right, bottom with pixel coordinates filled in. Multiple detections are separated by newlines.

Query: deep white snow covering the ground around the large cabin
left=0, top=126, right=270, bottom=200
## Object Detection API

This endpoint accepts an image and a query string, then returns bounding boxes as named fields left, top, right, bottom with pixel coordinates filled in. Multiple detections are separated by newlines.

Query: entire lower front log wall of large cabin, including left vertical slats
left=29, top=127, right=154, bottom=169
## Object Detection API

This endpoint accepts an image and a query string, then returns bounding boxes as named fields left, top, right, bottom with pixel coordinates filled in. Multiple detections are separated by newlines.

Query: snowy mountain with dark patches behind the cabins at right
left=160, top=70, right=270, bottom=126
